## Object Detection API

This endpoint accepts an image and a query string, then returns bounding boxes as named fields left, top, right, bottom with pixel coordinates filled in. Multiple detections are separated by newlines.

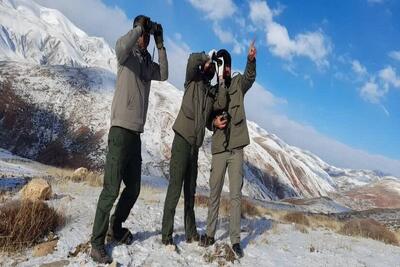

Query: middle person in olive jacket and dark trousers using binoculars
left=161, top=50, right=226, bottom=245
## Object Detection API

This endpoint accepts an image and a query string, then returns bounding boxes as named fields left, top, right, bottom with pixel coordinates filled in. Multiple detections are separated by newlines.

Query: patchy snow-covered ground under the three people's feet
left=0, top=176, right=400, bottom=266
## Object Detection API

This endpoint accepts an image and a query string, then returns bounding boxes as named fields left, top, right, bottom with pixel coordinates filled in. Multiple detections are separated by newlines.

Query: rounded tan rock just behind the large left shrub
left=21, top=178, right=52, bottom=201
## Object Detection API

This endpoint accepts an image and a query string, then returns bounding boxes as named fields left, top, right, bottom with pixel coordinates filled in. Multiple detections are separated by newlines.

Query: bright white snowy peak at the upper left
left=0, top=0, right=116, bottom=71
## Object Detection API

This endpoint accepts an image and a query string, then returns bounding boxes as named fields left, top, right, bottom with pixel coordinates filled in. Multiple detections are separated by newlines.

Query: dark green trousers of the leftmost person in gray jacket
left=91, top=127, right=142, bottom=248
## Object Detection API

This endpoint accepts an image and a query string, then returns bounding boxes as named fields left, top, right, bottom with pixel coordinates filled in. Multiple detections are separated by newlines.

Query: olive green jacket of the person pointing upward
left=208, top=59, right=256, bottom=154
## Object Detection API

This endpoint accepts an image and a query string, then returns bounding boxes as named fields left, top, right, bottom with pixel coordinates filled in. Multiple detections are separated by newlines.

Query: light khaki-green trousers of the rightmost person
left=207, top=148, right=243, bottom=244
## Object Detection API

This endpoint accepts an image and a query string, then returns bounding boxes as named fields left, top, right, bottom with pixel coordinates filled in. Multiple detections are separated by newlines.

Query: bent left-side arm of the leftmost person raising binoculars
left=115, top=25, right=143, bottom=65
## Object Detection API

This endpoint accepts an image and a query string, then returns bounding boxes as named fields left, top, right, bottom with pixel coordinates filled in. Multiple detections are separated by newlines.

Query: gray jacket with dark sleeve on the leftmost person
left=111, top=26, right=168, bottom=133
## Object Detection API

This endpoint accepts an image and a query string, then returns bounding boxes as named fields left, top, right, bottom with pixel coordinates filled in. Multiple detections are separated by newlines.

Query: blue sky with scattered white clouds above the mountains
left=36, top=0, right=400, bottom=176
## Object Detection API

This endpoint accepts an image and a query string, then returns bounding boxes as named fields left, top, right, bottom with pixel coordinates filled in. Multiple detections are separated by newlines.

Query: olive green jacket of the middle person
left=172, top=52, right=227, bottom=147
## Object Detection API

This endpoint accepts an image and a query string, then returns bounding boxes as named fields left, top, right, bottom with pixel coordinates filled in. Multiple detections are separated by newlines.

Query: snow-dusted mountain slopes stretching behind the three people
left=0, top=0, right=396, bottom=199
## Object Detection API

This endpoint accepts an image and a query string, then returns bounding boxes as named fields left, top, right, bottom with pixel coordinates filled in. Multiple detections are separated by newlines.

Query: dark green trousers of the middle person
left=161, top=134, right=199, bottom=241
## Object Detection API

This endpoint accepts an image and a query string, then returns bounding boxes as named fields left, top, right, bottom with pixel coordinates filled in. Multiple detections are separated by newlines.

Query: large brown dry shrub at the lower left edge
left=0, top=200, right=65, bottom=251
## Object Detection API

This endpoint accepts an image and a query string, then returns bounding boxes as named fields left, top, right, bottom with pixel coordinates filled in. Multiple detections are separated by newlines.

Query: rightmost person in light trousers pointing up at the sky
left=199, top=42, right=256, bottom=257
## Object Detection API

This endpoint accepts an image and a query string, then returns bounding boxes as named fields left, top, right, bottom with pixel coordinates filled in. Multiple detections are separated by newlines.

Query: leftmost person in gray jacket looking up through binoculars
left=91, top=15, right=168, bottom=263
